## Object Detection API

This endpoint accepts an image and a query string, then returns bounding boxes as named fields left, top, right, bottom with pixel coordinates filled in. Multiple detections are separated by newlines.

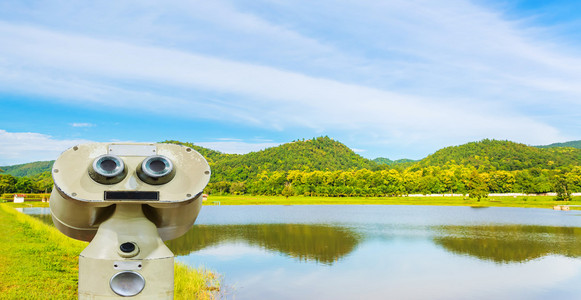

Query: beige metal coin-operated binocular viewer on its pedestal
left=50, top=143, right=210, bottom=299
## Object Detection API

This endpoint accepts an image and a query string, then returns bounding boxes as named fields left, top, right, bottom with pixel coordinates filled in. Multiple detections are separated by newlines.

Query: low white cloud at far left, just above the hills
left=0, top=129, right=89, bottom=166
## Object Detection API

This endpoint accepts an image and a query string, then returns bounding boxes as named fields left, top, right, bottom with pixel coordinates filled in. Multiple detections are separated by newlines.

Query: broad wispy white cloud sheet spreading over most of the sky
left=0, top=1, right=581, bottom=157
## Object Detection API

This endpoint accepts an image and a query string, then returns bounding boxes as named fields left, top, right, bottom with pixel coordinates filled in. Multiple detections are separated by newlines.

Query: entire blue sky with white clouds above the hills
left=0, top=0, right=581, bottom=165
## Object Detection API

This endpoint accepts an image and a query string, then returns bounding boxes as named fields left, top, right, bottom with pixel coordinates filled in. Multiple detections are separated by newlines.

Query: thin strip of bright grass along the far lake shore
left=204, top=195, right=581, bottom=209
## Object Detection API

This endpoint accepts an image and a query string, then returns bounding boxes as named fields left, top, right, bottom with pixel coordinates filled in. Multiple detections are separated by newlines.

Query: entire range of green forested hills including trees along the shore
left=0, top=137, right=581, bottom=199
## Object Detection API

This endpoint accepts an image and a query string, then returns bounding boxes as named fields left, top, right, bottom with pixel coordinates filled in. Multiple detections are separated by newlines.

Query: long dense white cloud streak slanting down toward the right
left=0, top=23, right=563, bottom=143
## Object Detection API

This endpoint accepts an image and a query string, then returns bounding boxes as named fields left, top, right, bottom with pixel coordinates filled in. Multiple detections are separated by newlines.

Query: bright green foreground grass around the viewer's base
left=0, top=202, right=220, bottom=299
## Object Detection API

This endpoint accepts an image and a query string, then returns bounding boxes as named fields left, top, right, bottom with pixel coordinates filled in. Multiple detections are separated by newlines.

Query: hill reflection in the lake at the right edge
left=434, top=225, right=581, bottom=263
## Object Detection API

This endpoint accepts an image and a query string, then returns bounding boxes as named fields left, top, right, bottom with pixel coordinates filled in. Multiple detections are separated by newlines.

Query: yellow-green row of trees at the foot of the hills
left=206, top=165, right=581, bottom=200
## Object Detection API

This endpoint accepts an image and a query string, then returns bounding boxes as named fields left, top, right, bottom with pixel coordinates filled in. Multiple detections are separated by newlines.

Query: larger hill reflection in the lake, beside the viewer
left=166, top=224, right=361, bottom=264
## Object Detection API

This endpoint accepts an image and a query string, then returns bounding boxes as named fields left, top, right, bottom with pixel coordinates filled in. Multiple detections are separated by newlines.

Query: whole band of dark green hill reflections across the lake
left=25, top=209, right=581, bottom=265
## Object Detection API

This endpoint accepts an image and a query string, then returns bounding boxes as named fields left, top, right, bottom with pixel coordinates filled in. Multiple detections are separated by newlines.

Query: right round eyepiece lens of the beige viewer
left=137, top=155, right=175, bottom=185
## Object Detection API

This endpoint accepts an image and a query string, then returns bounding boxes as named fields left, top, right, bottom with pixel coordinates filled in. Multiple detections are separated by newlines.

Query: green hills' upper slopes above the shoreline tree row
left=9, top=137, right=581, bottom=182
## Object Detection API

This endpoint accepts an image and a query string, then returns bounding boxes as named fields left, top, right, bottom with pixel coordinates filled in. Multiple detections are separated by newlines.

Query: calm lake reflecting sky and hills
left=25, top=205, right=581, bottom=299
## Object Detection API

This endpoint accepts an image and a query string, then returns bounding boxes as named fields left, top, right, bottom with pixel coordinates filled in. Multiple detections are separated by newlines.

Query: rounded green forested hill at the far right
left=419, top=139, right=581, bottom=171
